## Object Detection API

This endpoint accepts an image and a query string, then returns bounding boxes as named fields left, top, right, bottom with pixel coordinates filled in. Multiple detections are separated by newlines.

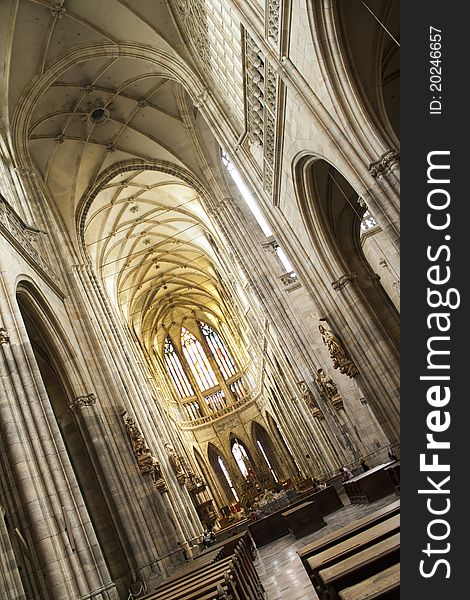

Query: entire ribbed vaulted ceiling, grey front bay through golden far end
left=0, top=0, right=242, bottom=344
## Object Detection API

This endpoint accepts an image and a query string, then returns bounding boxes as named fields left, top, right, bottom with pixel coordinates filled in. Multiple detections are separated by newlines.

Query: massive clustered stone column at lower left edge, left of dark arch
left=0, top=290, right=117, bottom=600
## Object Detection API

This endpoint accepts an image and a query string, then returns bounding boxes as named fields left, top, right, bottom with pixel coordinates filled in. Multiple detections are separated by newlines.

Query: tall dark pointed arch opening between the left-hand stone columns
left=17, top=280, right=131, bottom=589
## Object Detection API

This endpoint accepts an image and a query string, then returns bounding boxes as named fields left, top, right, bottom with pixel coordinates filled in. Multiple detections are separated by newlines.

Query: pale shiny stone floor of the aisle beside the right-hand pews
left=255, top=494, right=397, bottom=600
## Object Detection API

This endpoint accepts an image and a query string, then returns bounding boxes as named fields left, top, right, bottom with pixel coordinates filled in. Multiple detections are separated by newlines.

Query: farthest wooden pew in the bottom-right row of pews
left=297, top=500, right=400, bottom=572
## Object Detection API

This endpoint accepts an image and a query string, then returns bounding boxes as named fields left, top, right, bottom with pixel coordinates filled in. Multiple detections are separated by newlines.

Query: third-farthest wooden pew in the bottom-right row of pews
left=317, top=533, right=400, bottom=600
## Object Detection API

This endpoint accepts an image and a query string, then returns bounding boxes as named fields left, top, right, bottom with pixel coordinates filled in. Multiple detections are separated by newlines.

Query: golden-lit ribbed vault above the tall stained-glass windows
left=85, top=169, right=226, bottom=342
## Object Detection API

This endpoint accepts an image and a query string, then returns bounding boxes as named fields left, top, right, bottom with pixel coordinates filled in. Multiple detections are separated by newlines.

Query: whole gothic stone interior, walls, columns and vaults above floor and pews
left=0, top=0, right=400, bottom=600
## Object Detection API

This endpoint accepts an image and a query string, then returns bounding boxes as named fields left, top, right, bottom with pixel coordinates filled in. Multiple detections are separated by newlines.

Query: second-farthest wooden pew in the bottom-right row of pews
left=307, top=515, right=400, bottom=593
